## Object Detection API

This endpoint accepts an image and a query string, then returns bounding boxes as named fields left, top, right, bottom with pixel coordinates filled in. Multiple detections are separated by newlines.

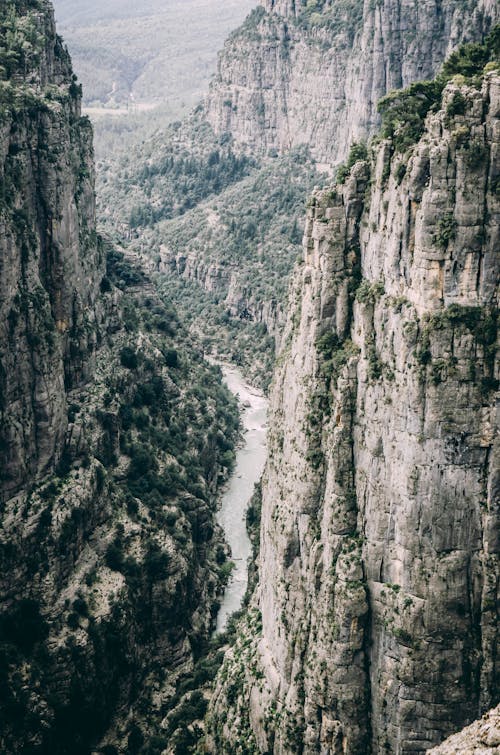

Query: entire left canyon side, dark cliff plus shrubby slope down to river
left=0, top=0, right=243, bottom=755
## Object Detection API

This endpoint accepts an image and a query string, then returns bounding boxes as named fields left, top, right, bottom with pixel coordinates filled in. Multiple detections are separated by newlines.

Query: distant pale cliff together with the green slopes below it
left=102, top=0, right=496, bottom=384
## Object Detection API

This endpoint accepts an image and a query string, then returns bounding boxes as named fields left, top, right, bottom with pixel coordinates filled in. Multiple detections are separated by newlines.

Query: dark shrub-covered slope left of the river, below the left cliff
left=0, top=233, right=239, bottom=755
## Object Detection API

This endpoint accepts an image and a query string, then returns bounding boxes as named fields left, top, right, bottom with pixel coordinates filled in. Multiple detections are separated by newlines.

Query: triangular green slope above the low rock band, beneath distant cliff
left=151, top=150, right=317, bottom=292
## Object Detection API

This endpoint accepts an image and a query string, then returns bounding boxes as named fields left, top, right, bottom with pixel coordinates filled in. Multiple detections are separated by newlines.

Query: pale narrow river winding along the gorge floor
left=216, top=365, right=267, bottom=632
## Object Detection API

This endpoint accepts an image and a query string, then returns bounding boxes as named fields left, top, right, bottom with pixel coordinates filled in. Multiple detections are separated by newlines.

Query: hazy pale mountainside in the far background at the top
left=54, top=0, right=256, bottom=113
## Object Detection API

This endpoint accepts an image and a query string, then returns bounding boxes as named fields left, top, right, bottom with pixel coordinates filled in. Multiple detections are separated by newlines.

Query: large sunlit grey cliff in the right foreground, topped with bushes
left=210, top=73, right=500, bottom=755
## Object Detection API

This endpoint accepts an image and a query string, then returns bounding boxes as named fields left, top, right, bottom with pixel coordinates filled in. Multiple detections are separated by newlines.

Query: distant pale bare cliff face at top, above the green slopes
left=206, top=0, right=498, bottom=164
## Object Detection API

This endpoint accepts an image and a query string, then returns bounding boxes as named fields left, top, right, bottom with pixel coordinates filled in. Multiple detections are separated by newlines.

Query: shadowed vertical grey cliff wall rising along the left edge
left=0, top=2, right=104, bottom=501
